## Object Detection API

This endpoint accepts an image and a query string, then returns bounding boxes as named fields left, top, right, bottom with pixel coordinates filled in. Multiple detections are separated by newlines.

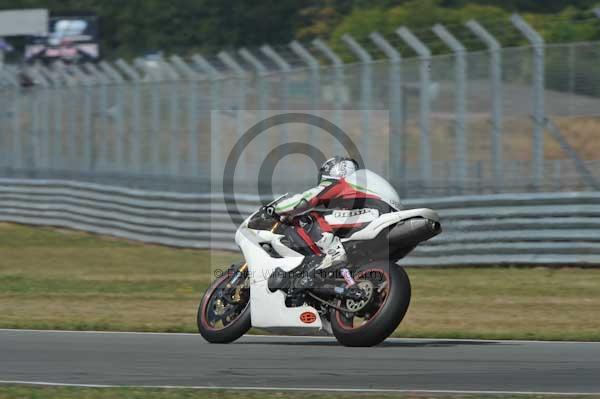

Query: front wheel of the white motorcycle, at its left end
left=197, top=265, right=251, bottom=344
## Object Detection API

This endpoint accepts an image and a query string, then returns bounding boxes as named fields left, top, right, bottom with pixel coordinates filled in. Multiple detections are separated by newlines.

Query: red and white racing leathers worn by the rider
left=275, top=170, right=393, bottom=269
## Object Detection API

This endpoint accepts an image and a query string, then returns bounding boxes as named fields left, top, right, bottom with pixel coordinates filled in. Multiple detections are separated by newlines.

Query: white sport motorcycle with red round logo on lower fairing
left=197, top=169, right=441, bottom=346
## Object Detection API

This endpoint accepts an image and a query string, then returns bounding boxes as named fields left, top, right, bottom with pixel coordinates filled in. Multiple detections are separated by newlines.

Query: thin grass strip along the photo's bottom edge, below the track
left=0, top=385, right=598, bottom=399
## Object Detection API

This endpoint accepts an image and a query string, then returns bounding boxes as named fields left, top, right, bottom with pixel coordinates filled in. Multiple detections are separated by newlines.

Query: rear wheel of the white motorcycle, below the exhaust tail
left=331, top=262, right=411, bottom=346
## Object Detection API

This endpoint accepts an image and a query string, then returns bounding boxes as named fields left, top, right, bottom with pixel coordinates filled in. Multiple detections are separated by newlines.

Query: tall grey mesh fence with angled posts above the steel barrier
left=0, top=15, right=600, bottom=197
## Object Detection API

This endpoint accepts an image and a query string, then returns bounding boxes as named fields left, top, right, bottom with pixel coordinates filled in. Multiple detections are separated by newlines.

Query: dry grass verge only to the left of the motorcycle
left=0, top=224, right=239, bottom=331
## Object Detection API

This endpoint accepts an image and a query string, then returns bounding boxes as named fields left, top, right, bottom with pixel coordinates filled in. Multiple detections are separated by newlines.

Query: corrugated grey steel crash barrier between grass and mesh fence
left=0, top=179, right=600, bottom=266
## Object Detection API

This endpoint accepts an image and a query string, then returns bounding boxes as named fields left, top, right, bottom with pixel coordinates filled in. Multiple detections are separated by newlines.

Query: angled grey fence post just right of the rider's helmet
left=342, top=33, right=373, bottom=161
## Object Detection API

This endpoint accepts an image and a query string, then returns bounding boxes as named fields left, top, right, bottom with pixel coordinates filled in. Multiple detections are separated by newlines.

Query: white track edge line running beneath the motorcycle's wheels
left=0, top=328, right=600, bottom=344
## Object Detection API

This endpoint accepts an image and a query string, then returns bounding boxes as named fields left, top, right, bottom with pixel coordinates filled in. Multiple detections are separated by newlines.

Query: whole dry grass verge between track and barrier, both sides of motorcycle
left=0, top=224, right=600, bottom=341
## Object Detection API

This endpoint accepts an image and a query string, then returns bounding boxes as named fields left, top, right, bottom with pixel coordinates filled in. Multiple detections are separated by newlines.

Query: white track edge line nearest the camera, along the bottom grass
left=0, top=380, right=600, bottom=396
